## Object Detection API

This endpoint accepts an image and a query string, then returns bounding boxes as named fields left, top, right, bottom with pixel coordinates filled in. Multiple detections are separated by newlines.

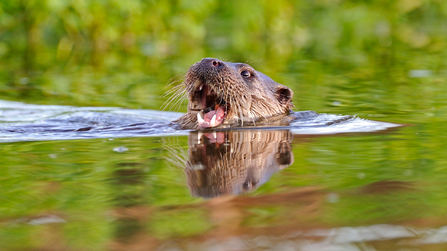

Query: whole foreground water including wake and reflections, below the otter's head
left=0, top=101, right=447, bottom=250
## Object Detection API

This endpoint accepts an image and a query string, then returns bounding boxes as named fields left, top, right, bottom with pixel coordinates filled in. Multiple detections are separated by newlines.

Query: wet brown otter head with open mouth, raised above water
left=177, top=58, right=293, bottom=129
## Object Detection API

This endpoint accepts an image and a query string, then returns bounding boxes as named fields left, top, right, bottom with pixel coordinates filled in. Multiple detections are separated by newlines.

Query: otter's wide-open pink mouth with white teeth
left=195, top=84, right=228, bottom=129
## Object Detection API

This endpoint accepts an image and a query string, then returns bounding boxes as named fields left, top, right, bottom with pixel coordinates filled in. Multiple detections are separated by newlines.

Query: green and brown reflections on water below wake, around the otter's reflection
left=0, top=127, right=445, bottom=250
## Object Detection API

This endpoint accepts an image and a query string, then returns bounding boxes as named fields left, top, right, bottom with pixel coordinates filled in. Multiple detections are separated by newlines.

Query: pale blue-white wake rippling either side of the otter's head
left=0, top=100, right=400, bottom=142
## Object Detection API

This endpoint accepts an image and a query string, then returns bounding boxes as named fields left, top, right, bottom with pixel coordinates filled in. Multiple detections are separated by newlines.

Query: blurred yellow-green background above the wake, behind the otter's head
left=0, top=0, right=447, bottom=118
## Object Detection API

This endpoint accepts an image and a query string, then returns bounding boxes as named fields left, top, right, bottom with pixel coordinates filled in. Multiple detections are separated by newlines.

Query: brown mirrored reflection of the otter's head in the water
left=185, top=130, right=293, bottom=198
